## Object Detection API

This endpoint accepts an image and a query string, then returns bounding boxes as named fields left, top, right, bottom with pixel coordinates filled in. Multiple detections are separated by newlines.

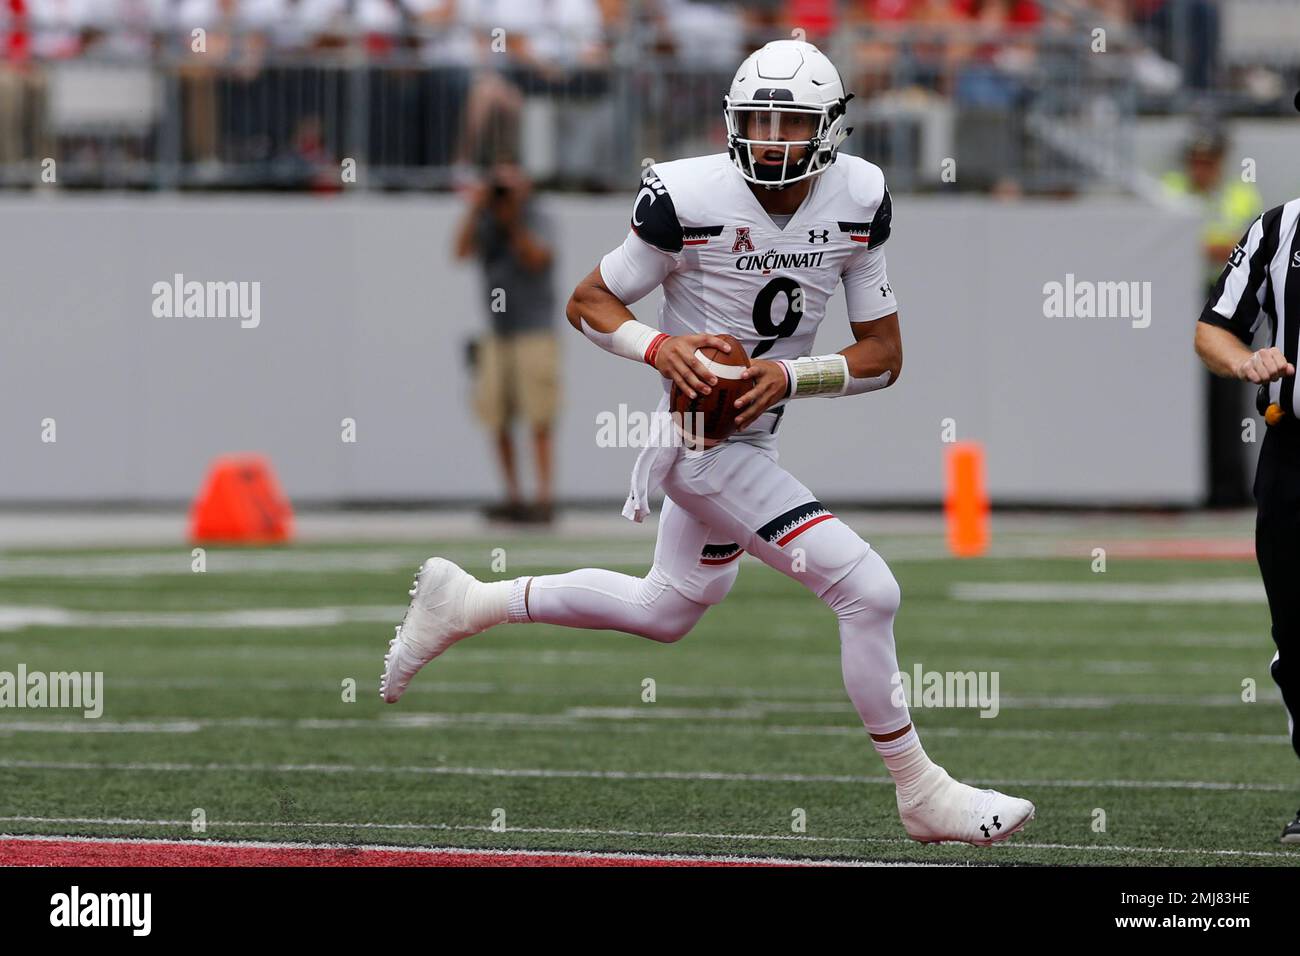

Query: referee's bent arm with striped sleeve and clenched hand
left=1196, top=213, right=1296, bottom=385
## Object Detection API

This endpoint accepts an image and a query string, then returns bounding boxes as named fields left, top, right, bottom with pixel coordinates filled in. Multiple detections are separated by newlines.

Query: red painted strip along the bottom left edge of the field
left=0, top=836, right=803, bottom=866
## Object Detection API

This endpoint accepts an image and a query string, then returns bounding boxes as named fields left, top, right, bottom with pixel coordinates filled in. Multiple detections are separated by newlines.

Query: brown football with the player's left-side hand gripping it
left=655, top=336, right=754, bottom=447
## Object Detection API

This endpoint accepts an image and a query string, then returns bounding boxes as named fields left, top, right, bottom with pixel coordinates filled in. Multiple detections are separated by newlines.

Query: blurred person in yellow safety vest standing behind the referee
left=1164, top=130, right=1264, bottom=507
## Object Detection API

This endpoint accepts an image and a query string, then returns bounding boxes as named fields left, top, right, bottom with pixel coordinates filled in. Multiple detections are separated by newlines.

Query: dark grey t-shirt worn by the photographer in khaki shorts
left=475, top=199, right=555, bottom=336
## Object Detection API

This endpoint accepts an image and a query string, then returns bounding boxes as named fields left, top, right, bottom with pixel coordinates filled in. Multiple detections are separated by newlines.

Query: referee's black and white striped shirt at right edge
left=1201, top=199, right=1300, bottom=418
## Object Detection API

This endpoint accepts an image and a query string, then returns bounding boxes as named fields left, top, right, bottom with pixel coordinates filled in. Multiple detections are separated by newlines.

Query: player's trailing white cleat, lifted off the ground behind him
left=380, top=558, right=478, bottom=704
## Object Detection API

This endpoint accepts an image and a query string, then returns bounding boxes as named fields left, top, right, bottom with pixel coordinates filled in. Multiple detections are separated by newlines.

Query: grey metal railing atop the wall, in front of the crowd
left=0, top=11, right=1274, bottom=194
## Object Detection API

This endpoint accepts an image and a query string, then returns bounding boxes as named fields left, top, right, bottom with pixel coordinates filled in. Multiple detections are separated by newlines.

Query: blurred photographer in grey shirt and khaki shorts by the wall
left=456, top=164, right=559, bottom=523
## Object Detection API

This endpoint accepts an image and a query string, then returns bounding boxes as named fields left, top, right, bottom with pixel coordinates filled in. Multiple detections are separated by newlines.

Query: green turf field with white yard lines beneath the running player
left=0, top=532, right=1300, bottom=865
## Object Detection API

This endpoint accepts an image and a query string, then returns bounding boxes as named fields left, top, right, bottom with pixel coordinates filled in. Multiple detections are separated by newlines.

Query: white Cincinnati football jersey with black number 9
left=601, top=153, right=898, bottom=388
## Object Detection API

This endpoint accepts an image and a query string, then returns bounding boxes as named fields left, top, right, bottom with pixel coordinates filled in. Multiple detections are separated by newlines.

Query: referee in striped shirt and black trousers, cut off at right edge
left=1196, top=188, right=1300, bottom=843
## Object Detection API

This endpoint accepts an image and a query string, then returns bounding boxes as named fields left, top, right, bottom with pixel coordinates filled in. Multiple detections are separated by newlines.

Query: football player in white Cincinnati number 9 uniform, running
left=381, top=40, right=1034, bottom=844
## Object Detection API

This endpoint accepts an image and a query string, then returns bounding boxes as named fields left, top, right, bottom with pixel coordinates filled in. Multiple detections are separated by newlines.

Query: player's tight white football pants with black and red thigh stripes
left=527, top=441, right=911, bottom=735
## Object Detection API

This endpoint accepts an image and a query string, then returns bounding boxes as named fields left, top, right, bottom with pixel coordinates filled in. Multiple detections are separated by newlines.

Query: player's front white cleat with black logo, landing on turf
left=897, top=765, right=1034, bottom=847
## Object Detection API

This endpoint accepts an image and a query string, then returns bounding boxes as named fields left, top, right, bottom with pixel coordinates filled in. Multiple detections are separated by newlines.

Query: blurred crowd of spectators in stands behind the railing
left=0, top=0, right=1263, bottom=186
